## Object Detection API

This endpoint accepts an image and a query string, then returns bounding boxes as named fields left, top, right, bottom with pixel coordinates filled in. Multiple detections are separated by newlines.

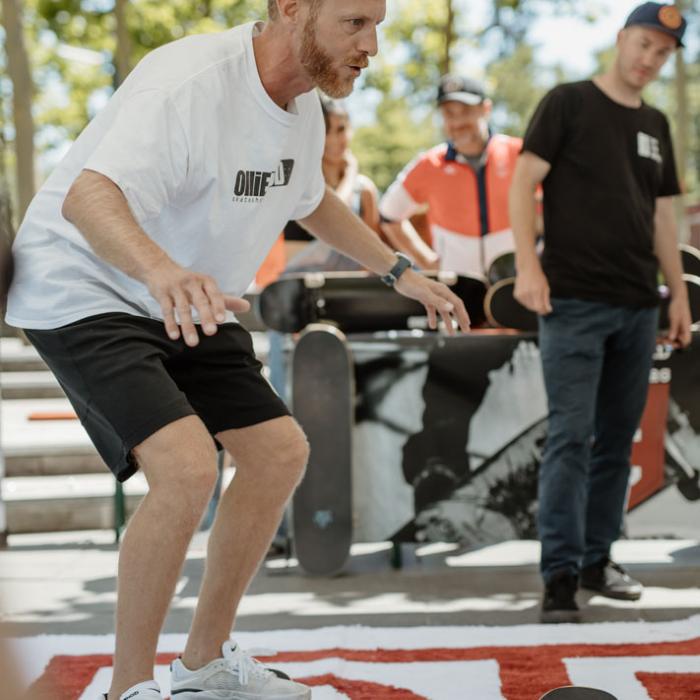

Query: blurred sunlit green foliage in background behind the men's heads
left=0, top=0, right=700, bottom=200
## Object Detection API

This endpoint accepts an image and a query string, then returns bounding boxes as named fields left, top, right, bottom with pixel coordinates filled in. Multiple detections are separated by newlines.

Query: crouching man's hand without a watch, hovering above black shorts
left=146, top=259, right=250, bottom=347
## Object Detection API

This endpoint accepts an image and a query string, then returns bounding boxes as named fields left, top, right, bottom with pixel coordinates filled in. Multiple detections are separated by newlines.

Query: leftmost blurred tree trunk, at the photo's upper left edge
left=2, top=0, right=35, bottom=220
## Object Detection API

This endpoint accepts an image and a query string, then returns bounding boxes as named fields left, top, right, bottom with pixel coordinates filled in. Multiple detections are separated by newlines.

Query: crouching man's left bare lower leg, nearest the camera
left=109, top=416, right=217, bottom=700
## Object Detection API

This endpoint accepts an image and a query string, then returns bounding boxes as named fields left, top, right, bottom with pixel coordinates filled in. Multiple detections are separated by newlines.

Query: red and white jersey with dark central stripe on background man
left=379, top=134, right=522, bottom=275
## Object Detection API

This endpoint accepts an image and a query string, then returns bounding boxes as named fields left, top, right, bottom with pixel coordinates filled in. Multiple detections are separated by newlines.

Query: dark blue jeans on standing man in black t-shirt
left=538, top=299, right=658, bottom=581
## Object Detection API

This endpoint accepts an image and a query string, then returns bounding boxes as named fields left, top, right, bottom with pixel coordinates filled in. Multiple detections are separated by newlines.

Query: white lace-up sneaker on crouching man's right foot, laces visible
left=170, top=641, right=311, bottom=700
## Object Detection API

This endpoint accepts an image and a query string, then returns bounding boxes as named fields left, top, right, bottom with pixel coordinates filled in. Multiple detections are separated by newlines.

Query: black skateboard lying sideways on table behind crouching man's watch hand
left=255, top=272, right=486, bottom=333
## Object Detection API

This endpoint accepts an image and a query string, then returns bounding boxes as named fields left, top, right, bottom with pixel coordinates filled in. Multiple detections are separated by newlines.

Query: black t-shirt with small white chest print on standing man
left=523, top=80, right=680, bottom=306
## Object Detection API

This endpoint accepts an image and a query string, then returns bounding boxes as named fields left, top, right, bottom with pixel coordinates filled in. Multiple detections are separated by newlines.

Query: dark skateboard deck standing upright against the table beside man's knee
left=292, top=324, right=354, bottom=576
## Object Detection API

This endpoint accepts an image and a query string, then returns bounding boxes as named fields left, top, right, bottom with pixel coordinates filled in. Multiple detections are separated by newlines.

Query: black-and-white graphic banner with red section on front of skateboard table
left=353, top=334, right=700, bottom=546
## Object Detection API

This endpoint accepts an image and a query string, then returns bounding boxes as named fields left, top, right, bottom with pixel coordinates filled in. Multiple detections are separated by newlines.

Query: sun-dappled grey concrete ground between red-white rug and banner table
left=0, top=531, right=700, bottom=636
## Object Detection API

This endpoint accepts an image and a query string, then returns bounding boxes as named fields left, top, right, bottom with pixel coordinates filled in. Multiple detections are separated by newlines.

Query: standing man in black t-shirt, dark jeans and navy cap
left=511, top=2, right=690, bottom=622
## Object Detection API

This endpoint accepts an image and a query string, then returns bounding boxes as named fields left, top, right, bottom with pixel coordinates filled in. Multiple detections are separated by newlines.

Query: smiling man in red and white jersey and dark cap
left=379, top=75, right=522, bottom=275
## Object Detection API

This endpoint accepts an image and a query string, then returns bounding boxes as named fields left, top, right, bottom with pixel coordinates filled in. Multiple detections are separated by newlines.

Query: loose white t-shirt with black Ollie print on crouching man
left=7, top=23, right=325, bottom=329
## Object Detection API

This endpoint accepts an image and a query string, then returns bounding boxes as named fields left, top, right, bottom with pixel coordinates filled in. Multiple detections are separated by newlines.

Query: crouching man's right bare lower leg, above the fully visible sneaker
left=182, top=417, right=309, bottom=670
